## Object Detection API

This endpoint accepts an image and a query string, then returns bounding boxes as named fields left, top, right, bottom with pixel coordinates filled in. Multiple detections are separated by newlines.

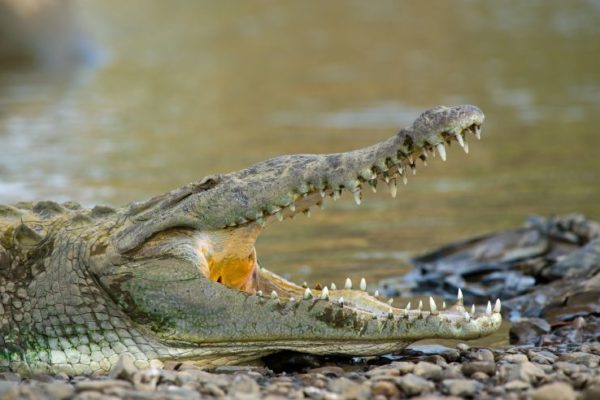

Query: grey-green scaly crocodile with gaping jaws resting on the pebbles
left=0, top=105, right=502, bottom=375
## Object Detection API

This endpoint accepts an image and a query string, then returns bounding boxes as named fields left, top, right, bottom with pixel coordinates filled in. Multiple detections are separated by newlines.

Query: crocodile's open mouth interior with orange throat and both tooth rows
left=197, top=115, right=500, bottom=321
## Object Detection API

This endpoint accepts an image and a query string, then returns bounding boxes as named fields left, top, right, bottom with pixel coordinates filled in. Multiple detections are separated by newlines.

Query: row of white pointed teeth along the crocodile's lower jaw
left=256, top=278, right=502, bottom=321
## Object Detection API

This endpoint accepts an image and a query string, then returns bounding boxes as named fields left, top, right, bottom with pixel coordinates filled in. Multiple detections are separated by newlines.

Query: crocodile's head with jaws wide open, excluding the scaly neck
left=90, top=106, right=501, bottom=364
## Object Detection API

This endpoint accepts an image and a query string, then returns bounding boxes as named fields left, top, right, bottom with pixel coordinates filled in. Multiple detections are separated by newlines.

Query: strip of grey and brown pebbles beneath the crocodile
left=0, top=342, right=600, bottom=400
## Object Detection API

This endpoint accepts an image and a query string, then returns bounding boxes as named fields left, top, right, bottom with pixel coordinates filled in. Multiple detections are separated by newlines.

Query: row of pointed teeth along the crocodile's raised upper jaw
left=227, top=125, right=481, bottom=227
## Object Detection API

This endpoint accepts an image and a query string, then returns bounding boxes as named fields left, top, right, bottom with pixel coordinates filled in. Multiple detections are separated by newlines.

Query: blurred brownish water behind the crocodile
left=0, top=0, right=600, bottom=285
